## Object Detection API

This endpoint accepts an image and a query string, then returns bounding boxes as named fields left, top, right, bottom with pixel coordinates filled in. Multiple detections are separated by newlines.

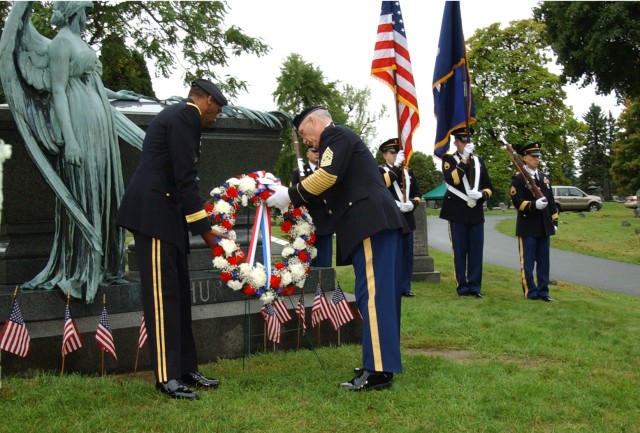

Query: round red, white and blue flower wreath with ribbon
left=206, top=171, right=316, bottom=304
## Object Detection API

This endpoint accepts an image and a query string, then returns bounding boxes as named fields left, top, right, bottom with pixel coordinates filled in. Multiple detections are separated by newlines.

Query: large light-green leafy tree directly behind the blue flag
left=468, top=20, right=580, bottom=202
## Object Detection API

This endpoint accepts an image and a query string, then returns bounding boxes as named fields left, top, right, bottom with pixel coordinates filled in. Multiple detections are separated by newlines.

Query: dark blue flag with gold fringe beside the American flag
left=433, top=1, right=476, bottom=158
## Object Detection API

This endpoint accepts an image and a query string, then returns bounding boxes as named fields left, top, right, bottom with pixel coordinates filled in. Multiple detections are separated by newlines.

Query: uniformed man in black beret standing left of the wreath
left=117, top=79, right=227, bottom=400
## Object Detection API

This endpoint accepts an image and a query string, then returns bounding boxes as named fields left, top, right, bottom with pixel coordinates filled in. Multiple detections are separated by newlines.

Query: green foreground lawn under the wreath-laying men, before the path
left=0, top=245, right=640, bottom=433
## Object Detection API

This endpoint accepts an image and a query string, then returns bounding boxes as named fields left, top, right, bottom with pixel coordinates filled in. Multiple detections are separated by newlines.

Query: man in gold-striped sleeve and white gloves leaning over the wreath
left=267, top=107, right=408, bottom=391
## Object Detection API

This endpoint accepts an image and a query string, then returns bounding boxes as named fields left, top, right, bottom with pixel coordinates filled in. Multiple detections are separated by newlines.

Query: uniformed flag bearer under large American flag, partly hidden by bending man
left=378, top=138, right=420, bottom=298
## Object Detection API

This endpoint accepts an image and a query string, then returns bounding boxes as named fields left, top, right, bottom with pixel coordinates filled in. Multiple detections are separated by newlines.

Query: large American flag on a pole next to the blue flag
left=371, top=1, right=420, bottom=166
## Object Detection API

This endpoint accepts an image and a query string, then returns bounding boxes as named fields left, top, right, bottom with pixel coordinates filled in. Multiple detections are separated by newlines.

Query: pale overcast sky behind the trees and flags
left=154, top=0, right=621, bottom=155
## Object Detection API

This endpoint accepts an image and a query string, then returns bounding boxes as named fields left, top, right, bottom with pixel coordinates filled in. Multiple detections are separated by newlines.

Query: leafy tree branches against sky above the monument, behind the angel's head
left=0, top=1, right=269, bottom=98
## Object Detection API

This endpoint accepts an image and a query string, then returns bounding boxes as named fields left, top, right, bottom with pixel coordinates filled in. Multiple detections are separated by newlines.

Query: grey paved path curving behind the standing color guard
left=427, top=215, right=640, bottom=296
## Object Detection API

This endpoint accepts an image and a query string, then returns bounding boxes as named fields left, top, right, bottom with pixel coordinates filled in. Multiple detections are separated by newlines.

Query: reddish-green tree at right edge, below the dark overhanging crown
left=610, top=98, right=640, bottom=196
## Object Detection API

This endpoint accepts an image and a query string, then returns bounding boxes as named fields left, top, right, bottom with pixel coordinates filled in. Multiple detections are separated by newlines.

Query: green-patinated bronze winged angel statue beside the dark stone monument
left=0, top=1, right=144, bottom=302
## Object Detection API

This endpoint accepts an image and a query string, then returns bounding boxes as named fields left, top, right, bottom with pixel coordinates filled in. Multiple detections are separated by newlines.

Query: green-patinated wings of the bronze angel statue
left=0, top=2, right=144, bottom=254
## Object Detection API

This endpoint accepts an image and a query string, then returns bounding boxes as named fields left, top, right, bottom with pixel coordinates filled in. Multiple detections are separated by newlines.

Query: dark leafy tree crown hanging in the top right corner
left=534, top=1, right=640, bottom=99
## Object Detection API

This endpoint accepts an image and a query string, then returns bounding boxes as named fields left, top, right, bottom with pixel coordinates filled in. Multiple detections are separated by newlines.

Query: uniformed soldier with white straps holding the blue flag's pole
left=440, top=128, right=493, bottom=298
